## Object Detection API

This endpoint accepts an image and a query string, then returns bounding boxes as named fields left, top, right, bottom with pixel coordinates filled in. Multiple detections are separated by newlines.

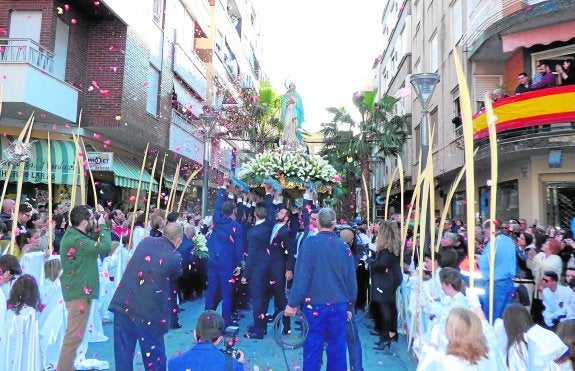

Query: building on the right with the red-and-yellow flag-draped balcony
left=376, top=0, right=575, bottom=227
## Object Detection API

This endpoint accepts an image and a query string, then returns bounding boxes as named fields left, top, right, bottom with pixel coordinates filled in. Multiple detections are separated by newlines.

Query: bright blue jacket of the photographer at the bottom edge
left=168, top=343, right=244, bottom=371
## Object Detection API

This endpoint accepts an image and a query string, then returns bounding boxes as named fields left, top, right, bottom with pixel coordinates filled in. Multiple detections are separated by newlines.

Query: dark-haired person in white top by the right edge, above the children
left=541, top=271, right=575, bottom=331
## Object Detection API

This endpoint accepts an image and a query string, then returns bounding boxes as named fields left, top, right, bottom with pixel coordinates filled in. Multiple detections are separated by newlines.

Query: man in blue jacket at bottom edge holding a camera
left=168, top=310, right=244, bottom=371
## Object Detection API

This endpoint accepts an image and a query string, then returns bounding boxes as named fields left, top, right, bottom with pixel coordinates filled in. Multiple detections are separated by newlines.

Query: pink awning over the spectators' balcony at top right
left=501, top=21, right=575, bottom=53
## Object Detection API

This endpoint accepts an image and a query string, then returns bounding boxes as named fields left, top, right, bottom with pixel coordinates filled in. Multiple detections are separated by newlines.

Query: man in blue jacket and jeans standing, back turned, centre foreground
left=284, top=208, right=357, bottom=371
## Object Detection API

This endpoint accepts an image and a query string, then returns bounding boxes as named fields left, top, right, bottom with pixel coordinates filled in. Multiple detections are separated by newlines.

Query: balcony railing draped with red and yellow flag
left=473, top=85, right=575, bottom=140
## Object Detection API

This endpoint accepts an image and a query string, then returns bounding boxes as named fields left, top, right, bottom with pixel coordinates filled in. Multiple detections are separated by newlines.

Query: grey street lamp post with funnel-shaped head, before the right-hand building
left=409, top=73, right=440, bottom=247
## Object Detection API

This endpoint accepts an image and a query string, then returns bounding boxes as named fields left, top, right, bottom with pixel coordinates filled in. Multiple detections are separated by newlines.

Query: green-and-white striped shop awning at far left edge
left=0, top=136, right=76, bottom=184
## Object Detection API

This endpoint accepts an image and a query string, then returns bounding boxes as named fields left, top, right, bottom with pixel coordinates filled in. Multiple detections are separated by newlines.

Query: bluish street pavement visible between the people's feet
left=87, top=299, right=416, bottom=371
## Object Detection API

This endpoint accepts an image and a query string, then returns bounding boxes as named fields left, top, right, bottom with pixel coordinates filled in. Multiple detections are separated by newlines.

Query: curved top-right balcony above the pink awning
left=462, top=0, right=575, bottom=61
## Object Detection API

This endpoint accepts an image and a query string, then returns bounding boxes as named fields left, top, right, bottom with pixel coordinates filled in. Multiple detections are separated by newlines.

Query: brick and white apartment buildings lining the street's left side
left=0, top=0, right=261, bottom=212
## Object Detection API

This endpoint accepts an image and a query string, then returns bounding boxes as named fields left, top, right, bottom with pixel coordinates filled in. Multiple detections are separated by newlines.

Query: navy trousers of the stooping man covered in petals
left=114, top=312, right=166, bottom=371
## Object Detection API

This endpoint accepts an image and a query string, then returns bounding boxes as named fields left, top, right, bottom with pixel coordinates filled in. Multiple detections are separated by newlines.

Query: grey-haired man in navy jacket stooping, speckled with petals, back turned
left=109, top=223, right=183, bottom=371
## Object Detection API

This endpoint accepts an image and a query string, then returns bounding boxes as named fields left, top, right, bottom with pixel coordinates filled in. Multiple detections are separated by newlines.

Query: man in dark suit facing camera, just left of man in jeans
left=266, top=199, right=295, bottom=334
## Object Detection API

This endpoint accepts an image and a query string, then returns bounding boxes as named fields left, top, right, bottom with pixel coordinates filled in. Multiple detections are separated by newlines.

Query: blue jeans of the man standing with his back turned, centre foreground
left=303, top=303, right=347, bottom=371
